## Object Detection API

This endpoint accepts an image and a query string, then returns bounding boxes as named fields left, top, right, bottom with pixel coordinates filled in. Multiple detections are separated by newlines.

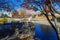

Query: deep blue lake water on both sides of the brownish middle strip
left=0, top=22, right=58, bottom=40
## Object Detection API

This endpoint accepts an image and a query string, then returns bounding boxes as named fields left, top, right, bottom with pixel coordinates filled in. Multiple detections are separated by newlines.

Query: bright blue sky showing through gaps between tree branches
left=0, top=0, right=60, bottom=10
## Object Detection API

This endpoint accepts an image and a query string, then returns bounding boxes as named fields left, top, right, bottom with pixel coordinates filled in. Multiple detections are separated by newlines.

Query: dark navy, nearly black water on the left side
left=0, top=22, right=24, bottom=38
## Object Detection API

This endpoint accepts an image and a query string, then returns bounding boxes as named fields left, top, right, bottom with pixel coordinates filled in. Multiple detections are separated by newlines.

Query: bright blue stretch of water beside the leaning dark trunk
left=35, top=24, right=58, bottom=40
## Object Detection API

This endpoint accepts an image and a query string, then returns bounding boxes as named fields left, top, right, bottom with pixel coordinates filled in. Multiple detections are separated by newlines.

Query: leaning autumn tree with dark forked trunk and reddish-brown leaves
left=22, top=0, right=60, bottom=39
